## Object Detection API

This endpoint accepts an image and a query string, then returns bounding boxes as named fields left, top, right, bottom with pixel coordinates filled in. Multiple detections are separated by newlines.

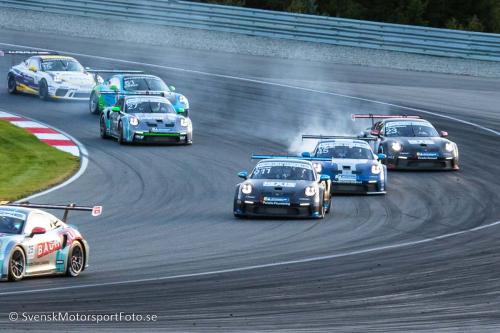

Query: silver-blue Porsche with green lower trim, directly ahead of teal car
left=100, top=92, right=193, bottom=144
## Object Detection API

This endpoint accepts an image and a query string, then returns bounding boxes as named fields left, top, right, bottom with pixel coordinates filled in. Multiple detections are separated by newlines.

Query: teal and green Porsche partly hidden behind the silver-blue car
left=89, top=70, right=189, bottom=117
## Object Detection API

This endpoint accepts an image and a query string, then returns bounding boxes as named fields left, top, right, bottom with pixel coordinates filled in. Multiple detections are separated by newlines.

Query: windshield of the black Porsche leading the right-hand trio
left=250, top=162, right=314, bottom=181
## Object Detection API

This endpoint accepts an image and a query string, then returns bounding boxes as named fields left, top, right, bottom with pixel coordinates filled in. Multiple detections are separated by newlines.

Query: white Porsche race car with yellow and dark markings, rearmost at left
left=0, top=51, right=96, bottom=100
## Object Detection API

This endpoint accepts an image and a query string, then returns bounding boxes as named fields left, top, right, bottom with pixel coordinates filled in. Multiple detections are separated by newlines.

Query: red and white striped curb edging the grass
left=0, top=111, right=80, bottom=157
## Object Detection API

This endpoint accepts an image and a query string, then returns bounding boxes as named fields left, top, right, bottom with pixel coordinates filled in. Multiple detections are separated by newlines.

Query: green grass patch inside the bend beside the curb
left=0, top=121, right=80, bottom=201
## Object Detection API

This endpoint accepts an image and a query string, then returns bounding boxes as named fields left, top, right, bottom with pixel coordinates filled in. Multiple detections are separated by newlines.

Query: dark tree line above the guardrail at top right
left=192, top=0, right=500, bottom=33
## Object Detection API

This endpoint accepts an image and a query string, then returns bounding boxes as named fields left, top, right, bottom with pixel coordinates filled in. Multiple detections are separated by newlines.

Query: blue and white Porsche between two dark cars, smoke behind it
left=302, top=135, right=387, bottom=194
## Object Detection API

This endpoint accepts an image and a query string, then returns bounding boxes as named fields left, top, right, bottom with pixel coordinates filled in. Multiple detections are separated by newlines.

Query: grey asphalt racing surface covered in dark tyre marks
left=0, top=31, right=500, bottom=332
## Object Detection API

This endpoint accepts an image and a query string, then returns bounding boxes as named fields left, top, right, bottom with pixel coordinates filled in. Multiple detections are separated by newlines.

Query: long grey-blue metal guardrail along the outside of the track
left=0, top=0, right=500, bottom=61
